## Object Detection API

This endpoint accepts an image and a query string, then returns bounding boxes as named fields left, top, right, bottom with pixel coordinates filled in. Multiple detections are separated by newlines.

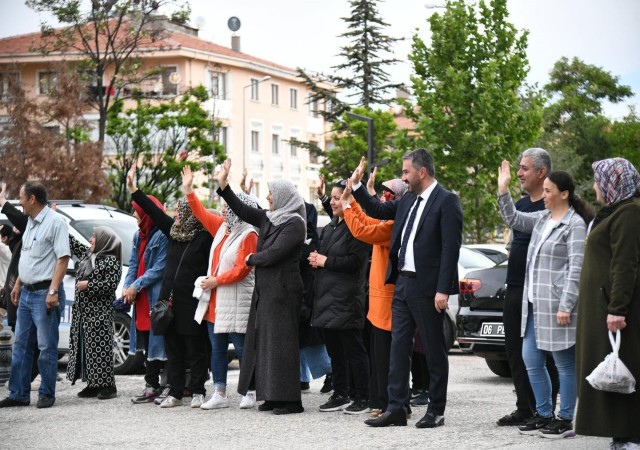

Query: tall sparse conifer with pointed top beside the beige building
left=298, top=0, right=402, bottom=121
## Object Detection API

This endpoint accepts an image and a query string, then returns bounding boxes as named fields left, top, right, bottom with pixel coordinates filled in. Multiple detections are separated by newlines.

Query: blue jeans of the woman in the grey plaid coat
left=522, top=304, right=577, bottom=420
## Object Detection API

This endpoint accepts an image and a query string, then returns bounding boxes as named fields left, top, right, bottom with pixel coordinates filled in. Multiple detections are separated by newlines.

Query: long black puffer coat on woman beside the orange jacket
left=311, top=217, right=370, bottom=330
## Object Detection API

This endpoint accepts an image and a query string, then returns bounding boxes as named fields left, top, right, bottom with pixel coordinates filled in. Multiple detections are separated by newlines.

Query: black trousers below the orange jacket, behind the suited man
left=369, top=325, right=391, bottom=410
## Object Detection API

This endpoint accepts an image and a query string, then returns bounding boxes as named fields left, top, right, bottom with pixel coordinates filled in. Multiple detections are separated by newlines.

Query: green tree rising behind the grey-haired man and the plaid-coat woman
left=541, top=57, right=633, bottom=192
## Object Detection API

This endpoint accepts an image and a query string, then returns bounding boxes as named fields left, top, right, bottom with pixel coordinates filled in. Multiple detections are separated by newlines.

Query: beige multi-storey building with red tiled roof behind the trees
left=0, top=18, right=330, bottom=200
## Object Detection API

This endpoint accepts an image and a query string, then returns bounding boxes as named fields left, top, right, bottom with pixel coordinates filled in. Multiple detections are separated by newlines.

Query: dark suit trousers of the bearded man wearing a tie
left=387, top=276, right=449, bottom=415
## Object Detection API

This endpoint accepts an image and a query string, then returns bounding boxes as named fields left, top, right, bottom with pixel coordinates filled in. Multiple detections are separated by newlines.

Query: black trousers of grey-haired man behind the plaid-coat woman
left=502, top=286, right=560, bottom=414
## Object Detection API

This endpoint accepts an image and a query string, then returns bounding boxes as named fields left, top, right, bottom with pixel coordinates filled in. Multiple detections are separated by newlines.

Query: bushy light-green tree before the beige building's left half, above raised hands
left=107, top=86, right=225, bottom=210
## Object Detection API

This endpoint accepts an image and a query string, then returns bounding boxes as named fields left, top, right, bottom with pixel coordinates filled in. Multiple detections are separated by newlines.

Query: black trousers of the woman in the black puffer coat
left=324, top=328, right=369, bottom=400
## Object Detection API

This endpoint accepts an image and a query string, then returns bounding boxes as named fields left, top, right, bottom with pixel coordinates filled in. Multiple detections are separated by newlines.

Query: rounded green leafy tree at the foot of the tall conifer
left=320, top=107, right=413, bottom=186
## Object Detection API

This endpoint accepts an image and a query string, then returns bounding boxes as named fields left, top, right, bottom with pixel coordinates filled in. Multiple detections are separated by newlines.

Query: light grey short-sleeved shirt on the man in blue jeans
left=18, top=206, right=71, bottom=284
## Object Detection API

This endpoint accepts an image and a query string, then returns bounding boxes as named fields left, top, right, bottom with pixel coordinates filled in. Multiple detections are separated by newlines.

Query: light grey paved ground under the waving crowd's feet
left=0, top=353, right=608, bottom=450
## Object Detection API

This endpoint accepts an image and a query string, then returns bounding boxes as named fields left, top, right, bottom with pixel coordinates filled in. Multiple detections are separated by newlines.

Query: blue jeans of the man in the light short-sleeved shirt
left=9, top=286, right=65, bottom=402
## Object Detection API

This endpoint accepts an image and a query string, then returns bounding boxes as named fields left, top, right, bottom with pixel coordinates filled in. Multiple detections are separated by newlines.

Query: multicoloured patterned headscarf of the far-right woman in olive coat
left=591, top=158, right=640, bottom=206
